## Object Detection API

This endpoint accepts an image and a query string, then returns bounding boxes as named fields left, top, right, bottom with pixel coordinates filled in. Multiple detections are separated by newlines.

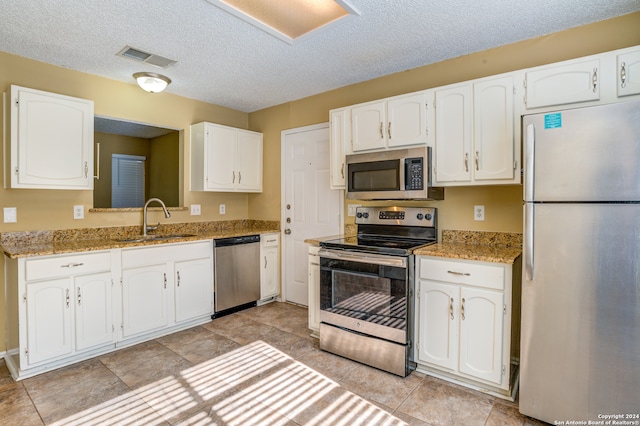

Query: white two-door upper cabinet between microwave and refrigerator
left=434, top=75, right=520, bottom=186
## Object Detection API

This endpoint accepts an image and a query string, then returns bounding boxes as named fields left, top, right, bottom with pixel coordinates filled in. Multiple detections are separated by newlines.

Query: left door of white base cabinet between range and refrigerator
left=417, top=280, right=459, bottom=370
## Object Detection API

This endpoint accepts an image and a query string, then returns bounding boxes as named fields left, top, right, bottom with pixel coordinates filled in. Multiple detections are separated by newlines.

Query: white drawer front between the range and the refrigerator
left=419, top=258, right=504, bottom=290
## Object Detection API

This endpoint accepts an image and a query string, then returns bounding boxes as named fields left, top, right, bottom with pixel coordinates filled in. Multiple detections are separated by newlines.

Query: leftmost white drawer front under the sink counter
left=25, top=252, right=111, bottom=281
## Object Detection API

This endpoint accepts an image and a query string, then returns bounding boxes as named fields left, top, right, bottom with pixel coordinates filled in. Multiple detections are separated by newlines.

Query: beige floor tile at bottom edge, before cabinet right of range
left=397, top=376, right=493, bottom=426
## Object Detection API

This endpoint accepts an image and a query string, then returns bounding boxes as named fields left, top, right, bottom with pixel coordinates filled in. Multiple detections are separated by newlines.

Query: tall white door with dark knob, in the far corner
left=282, top=123, right=344, bottom=306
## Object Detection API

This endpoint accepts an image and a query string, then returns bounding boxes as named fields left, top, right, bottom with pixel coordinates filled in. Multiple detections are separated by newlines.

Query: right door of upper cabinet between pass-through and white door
left=236, top=130, right=262, bottom=192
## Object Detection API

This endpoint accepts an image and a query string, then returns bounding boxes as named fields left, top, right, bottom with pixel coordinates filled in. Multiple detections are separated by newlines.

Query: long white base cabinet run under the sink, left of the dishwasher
left=5, top=240, right=213, bottom=379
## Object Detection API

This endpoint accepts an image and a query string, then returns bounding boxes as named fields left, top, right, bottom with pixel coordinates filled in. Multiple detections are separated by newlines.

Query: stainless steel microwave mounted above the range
left=347, top=146, right=444, bottom=200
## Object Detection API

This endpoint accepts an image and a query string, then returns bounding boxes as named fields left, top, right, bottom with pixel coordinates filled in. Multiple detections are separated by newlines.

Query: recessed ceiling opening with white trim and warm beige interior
left=208, top=0, right=358, bottom=43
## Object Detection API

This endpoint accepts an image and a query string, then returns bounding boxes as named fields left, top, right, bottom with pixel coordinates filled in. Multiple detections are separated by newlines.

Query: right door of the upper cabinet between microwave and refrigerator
left=472, top=76, right=515, bottom=180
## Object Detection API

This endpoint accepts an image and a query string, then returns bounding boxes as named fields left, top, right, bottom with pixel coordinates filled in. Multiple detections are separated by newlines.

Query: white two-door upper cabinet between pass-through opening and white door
left=191, top=123, right=262, bottom=192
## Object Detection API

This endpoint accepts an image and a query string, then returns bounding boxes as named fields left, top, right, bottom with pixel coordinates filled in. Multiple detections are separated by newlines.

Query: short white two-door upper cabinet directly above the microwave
left=347, top=91, right=427, bottom=152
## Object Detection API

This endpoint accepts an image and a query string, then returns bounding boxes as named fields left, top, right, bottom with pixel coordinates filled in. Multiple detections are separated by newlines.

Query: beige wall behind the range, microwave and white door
left=249, top=13, right=640, bottom=232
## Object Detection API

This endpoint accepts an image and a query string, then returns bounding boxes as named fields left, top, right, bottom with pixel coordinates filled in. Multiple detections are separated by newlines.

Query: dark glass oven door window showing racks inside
left=320, top=258, right=407, bottom=330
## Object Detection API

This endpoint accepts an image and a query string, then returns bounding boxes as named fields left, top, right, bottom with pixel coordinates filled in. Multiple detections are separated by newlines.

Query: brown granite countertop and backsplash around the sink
left=0, top=220, right=280, bottom=259
